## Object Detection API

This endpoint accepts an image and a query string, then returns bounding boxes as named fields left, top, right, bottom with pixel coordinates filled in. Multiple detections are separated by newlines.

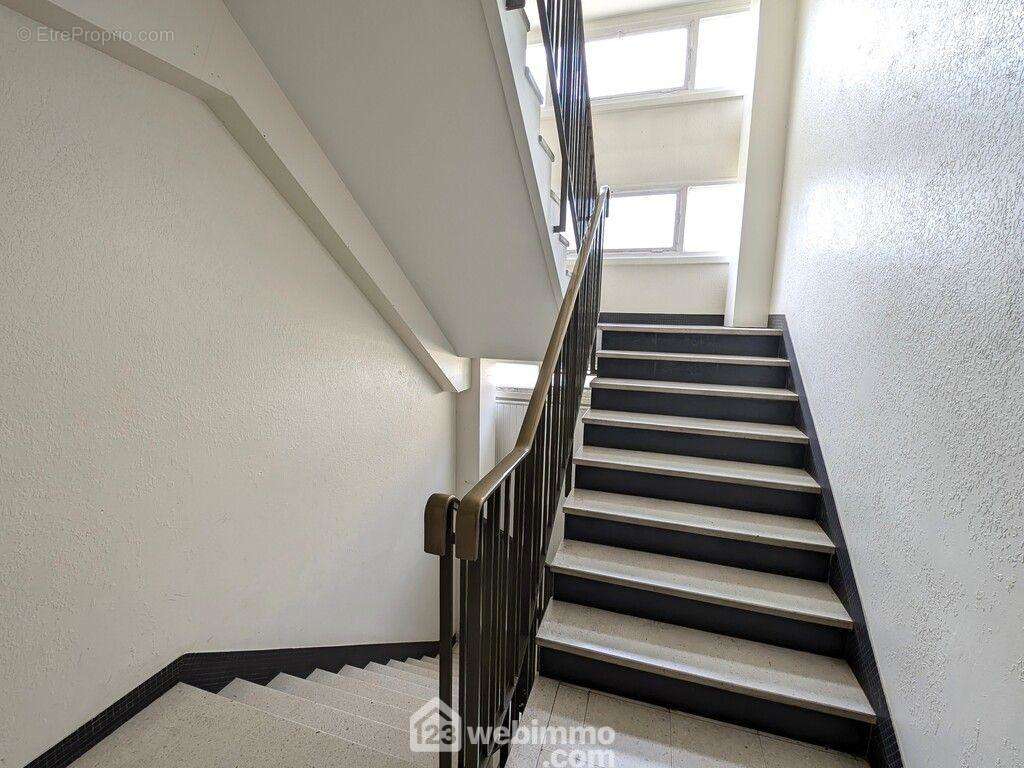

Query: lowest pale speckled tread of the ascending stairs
left=538, top=600, right=876, bottom=723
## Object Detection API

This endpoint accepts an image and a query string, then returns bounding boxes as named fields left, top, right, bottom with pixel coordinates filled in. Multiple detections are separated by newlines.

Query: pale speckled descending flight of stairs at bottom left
left=75, top=658, right=437, bottom=768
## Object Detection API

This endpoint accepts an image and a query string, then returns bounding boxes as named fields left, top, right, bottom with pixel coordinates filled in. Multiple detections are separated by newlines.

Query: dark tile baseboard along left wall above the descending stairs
left=26, top=642, right=437, bottom=768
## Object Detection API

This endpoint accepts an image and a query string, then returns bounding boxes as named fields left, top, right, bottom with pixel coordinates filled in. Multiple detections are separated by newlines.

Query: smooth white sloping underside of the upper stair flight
left=226, top=0, right=558, bottom=359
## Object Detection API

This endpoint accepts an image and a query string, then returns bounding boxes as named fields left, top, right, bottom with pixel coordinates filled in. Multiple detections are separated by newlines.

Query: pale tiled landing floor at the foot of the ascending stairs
left=508, top=678, right=867, bottom=768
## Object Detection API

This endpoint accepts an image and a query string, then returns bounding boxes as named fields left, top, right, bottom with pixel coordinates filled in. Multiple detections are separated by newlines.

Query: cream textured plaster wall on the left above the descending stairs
left=0, top=8, right=454, bottom=766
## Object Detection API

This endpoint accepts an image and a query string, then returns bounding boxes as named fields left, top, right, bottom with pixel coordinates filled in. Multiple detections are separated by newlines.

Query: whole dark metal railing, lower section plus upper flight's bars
left=424, top=0, right=609, bottom=768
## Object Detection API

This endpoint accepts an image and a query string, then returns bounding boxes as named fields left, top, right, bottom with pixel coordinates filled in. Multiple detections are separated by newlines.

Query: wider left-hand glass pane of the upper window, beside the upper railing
left=587, top=28, right=687, bottom=98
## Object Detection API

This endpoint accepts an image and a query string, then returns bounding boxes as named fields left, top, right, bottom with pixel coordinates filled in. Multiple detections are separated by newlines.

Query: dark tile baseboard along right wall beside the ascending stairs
left=768, top=314, right=903, bottom=768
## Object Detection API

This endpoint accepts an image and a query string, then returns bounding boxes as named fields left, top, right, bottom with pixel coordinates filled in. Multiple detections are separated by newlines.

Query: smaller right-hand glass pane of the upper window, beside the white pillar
left=694, top=11, right=754, bottom=90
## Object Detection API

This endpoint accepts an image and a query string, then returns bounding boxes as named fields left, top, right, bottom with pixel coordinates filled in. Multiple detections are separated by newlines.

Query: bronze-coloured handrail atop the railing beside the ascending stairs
left=455, top=186, right=609, bottom=560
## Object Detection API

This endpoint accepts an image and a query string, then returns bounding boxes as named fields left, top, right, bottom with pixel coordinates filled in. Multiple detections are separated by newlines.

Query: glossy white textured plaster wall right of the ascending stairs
left=773, top=0, right=1024, bottom=768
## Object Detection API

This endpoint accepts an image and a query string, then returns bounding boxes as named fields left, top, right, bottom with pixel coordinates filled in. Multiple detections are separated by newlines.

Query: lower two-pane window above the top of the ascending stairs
left=604, top=183, right=743, bottom=255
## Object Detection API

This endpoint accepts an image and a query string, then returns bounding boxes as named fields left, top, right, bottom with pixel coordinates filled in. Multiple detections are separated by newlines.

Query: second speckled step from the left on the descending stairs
left=220, top=679, right=421, bottom=765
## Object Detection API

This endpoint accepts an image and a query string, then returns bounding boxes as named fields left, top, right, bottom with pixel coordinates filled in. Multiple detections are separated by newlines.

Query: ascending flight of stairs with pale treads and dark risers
left=539, top=324, right=874, bottom=754
